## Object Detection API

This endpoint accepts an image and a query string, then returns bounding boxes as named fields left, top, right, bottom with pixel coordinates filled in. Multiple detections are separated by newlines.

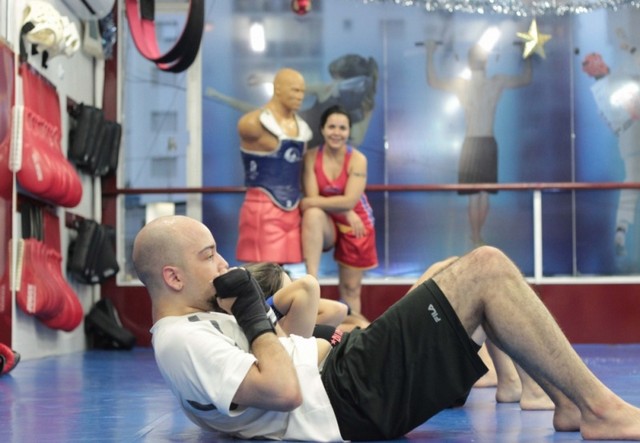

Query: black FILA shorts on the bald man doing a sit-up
left=322, top=280, right=487, bottom=440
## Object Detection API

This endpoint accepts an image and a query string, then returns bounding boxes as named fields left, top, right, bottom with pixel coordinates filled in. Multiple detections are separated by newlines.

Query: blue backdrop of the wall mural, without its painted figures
left=202, top=1, right=640, bottom=275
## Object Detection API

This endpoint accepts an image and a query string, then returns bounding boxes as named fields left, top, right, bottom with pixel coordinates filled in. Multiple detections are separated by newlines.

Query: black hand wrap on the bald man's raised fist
left=213, top=268, right=275, bottom=345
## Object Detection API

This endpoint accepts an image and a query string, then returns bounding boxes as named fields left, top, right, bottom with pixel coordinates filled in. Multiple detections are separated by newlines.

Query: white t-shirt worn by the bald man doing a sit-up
left=151, top=312, right=343, bottom=441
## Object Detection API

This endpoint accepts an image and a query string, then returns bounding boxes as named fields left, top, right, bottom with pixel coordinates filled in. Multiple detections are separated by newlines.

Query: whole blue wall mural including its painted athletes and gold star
left=196, top=1, right=640, bottom=276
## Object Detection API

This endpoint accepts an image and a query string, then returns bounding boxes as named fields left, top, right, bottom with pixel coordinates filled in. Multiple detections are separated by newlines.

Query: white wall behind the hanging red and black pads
left=0, top=0, right=102, bottom=359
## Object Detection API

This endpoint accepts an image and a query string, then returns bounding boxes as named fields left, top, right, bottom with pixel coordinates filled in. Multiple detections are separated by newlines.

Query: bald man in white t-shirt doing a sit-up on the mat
left=133, top=216, right=640, bottom=441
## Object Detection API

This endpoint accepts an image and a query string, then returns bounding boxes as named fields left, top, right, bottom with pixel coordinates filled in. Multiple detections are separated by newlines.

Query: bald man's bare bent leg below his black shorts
left=434, top=246, right=640, bottom=440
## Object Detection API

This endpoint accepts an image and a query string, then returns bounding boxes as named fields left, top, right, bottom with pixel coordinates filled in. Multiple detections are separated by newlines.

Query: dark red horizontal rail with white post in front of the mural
left=110, top=182, right=640, bottom=284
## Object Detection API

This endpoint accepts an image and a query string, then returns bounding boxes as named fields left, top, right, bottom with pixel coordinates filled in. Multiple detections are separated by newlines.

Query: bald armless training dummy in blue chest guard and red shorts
left=236, top=68, right=312, bottom=264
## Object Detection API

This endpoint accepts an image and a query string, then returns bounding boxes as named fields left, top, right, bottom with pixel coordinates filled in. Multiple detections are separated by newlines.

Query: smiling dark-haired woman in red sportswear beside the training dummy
left=300, top=106, right=378, bottom=314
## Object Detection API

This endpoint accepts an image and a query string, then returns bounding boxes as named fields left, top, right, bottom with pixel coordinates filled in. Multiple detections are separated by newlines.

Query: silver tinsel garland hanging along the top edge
left=363, top=0, right=640, bottom=17
